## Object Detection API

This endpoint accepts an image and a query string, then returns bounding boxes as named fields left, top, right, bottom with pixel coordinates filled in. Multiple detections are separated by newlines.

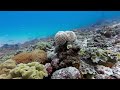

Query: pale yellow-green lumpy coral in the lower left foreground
left=8, top=62, right=48, bottom=79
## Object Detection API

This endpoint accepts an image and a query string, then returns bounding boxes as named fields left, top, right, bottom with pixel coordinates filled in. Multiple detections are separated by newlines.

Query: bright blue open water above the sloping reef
left=0, top=11, right=120, bottom=46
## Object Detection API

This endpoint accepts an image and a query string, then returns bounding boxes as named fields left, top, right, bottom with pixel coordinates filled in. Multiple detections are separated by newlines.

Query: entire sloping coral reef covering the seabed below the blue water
left=0, top=18, right=120, bottom=79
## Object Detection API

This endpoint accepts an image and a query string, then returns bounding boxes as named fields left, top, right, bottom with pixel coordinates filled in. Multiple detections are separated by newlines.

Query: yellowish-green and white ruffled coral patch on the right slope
left=79, top=48, right=119, bottom=64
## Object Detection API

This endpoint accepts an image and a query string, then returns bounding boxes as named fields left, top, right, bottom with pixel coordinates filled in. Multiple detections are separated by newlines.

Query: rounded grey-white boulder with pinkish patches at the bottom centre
left=51, top=67, right=81, bottom=79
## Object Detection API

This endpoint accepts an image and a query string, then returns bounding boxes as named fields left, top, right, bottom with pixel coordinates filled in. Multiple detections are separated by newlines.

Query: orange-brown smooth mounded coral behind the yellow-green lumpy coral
left=12, top=50, right=47, bottom=64
